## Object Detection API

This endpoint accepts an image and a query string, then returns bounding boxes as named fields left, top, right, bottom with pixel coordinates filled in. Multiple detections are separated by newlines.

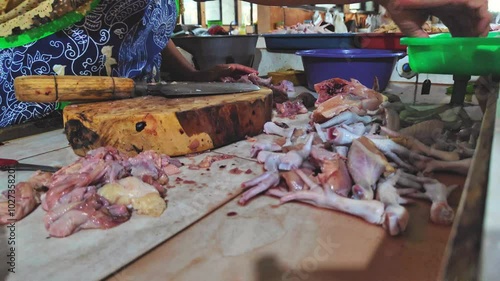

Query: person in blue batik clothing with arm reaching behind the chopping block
left=0, top=0, right=255, bottom=128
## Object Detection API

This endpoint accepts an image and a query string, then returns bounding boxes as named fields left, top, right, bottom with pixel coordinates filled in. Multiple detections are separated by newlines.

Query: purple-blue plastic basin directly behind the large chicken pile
left=295, top=49, right=405, bottom=91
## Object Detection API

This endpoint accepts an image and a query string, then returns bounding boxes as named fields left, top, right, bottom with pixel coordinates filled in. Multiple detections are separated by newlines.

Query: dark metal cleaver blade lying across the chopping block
left=136, top=82, right=260, bottom=97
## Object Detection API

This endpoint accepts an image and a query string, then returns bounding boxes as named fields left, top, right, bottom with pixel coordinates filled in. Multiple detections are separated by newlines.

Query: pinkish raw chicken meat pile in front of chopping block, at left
left=0, top=147, right=181, bottom=237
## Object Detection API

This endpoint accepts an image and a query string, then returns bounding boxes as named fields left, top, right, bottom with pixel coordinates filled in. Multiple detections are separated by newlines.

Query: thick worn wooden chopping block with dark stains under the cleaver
left=63, top=88, right=273, bottom=156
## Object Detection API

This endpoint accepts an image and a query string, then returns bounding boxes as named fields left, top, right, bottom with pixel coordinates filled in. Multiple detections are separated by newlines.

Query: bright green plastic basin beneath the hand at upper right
left=400, top=32, right=500, bottom=75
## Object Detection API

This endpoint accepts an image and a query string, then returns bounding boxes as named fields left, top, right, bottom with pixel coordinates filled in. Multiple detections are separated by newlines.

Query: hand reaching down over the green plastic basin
left=378, top=0, right=491, bottom=37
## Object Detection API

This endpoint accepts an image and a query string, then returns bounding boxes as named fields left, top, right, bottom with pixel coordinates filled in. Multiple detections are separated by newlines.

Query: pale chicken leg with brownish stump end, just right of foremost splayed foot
left=377, top=173, right=410, bottom=235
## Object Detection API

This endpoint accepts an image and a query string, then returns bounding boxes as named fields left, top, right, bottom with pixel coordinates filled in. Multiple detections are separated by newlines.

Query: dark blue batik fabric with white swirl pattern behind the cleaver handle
left=0, top=0, right=177, bottom=127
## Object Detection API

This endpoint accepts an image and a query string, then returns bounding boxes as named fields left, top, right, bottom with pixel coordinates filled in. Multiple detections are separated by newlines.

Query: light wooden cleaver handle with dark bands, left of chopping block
left=14, top=75, right=135, bottom=102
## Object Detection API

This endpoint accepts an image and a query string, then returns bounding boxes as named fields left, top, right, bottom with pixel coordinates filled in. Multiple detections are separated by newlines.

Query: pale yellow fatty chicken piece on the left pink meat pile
left=97, top=177, right=167, bottom=217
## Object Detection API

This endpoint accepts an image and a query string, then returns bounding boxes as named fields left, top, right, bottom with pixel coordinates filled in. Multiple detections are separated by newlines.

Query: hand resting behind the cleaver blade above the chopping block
left=193, top=63, right=257, bottom=82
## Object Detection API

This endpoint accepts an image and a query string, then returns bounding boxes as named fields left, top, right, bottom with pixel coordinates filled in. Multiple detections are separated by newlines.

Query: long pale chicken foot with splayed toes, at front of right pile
left=280, top=167, right=384, bottom=225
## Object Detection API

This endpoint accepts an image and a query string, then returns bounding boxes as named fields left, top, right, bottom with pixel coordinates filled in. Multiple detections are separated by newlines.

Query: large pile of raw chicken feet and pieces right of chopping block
left=239, top=78, right=473, bottom=235
